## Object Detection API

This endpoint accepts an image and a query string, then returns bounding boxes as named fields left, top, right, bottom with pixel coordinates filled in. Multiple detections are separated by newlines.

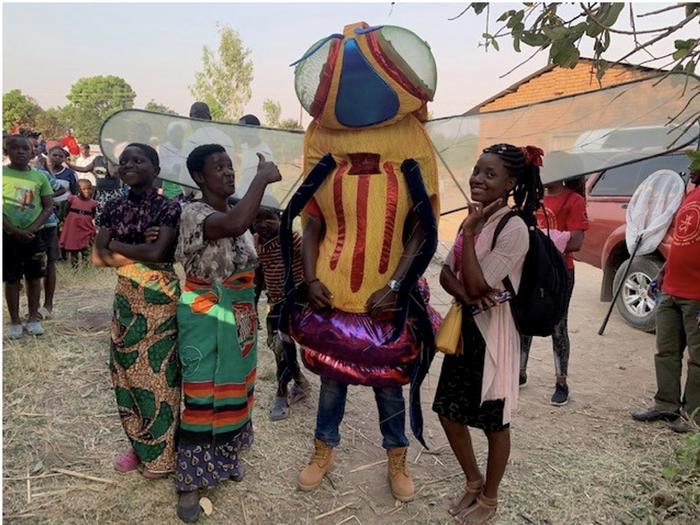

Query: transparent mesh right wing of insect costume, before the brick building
left=426, top=74, right=700, bottom=212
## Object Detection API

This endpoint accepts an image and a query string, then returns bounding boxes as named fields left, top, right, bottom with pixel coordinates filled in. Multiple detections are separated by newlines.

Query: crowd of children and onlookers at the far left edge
left=3, top=128, right=133, bottom=338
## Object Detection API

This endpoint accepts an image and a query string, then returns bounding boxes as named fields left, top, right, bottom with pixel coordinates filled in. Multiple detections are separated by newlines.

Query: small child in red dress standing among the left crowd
left=59, top=179, right=97, bottom=268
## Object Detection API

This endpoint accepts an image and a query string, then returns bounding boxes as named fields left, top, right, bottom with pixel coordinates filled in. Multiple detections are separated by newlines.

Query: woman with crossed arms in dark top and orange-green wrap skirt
left=93, top=144, right=180, bottom=478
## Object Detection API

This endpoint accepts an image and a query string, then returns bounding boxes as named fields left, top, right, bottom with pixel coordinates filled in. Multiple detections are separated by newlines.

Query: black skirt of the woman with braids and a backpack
left=433, top=313, right=510, bottom=432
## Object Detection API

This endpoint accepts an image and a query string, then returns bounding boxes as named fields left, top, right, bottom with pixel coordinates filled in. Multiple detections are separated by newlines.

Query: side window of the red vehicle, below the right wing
left=590, top=155, right=688, bottom=197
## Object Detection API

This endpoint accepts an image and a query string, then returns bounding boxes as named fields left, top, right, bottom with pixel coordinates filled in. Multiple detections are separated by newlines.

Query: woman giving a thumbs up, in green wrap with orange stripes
left=175, top=144, right=281, bottom=523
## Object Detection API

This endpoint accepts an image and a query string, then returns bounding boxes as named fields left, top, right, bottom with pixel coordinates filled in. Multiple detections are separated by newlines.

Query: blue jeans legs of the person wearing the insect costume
left=316, top=377, right=408, bottom=449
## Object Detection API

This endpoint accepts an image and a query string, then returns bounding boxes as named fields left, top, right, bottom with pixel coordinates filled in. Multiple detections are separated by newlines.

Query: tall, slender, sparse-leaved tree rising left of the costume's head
left=190, top=25, right=253, bottom=121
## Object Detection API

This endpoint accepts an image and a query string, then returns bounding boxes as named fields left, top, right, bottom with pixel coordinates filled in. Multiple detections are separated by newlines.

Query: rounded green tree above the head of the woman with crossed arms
left=63, top=75, right=136, bottom=143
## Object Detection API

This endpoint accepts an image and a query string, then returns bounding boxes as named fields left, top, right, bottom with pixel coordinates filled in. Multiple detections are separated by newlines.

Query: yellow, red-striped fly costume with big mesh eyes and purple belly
left=280, top=22, right=440, bottom=443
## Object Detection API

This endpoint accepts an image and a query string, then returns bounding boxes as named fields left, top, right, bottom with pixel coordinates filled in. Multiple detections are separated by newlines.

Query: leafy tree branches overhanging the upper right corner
left=460, top=2, right=700, bottom=134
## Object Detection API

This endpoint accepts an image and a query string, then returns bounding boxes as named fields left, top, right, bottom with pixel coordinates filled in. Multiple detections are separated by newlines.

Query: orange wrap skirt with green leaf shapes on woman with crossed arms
left=110, top=263, right=181, bottom=473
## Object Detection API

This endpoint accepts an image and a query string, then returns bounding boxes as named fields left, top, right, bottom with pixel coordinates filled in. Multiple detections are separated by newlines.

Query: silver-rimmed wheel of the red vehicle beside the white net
left=613, top=256, right=663, bottom=332
